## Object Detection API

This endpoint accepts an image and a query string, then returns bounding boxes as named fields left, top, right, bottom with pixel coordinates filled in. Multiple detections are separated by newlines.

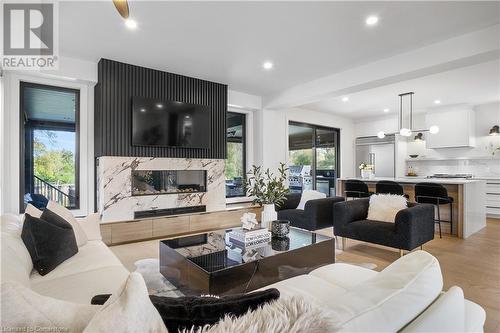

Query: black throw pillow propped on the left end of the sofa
left=21, top=213, right=78, bottom=275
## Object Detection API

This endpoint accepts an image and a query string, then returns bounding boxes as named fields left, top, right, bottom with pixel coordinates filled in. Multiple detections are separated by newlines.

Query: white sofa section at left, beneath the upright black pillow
left=1, top=214, right=130, bottom=304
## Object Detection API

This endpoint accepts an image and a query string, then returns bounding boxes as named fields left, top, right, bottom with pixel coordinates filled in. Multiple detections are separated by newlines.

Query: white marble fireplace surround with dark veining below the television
left=97, top=156, right=226, bottom=222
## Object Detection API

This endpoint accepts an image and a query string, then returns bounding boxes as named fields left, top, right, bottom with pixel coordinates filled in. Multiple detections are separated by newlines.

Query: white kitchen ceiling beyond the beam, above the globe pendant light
left=302, top=60, right=500, bottom=118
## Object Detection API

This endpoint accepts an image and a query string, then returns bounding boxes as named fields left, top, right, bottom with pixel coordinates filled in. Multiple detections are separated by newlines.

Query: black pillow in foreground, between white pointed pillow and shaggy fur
left=91, top=288, right=280, bottom=332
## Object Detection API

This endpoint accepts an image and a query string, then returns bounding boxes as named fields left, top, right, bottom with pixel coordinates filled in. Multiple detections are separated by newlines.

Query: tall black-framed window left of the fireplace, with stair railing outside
left=20, top=82, right=80, bottom=211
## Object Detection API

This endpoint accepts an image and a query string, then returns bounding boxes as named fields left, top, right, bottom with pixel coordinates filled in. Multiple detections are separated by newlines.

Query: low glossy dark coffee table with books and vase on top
left=160, top=227, right=335, bottom=295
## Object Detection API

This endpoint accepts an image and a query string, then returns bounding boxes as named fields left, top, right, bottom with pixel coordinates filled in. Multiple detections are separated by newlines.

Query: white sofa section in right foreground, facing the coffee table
left=264, top=251, right=486, bottom=333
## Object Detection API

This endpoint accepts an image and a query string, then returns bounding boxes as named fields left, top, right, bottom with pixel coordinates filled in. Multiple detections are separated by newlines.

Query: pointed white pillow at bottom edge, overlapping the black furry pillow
left=84, top=273, right=168, bottom=333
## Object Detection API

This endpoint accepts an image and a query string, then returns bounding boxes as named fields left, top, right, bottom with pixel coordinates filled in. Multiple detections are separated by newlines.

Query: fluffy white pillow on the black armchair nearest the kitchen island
left=367, top=194, right=407, bottom=223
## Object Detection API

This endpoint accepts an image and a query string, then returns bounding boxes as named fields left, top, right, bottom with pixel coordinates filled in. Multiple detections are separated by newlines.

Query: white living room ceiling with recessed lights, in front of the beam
left=59, top=0, right=500, bottom=97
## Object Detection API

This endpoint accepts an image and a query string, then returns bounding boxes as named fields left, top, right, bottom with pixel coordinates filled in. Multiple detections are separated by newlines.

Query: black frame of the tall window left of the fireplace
left=18, top=80, right=82, bottom=213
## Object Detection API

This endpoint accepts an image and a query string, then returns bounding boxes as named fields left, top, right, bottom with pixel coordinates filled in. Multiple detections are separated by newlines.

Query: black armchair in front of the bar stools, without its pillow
left=333, top=198, right=434, bottom=251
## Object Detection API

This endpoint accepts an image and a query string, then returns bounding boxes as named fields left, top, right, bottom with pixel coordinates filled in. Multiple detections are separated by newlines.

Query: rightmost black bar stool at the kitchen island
left=415, top=183, right=453, bottom=238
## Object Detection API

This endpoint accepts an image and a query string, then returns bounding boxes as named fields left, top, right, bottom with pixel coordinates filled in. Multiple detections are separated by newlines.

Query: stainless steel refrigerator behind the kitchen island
left=356, top=135, right=396, bottom=177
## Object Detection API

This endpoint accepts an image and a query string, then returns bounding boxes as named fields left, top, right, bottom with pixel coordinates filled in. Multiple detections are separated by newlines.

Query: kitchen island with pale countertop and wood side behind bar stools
left=337, top=177, right=486, bottom=238
